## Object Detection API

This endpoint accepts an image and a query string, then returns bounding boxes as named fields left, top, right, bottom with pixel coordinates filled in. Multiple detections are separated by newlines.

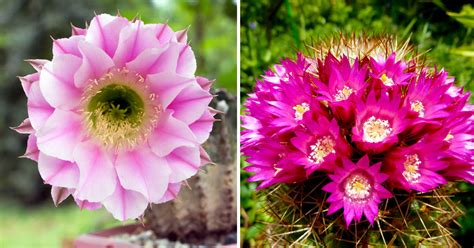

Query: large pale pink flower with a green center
left=17, top=14, right=214, bottom=220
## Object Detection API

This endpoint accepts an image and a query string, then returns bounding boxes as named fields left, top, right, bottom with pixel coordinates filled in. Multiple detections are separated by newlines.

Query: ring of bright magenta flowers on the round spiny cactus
left=241, top=52, right=474, bottom=225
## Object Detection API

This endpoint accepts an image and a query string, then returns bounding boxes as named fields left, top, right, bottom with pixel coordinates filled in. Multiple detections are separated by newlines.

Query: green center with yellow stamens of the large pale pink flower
left=83, top=69, right=160, bottom=149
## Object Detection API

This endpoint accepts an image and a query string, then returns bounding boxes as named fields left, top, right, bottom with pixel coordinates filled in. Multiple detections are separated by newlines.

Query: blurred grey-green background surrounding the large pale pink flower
left=0, top=0, right=237, bottom=248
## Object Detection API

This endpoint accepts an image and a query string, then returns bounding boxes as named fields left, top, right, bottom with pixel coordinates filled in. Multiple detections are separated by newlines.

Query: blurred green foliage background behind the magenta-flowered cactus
left=240, top=0, right=474, bottom=247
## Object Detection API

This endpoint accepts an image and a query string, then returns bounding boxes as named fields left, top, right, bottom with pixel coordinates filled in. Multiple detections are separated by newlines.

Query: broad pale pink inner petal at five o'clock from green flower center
left=115, top=148, right=171, bottom=202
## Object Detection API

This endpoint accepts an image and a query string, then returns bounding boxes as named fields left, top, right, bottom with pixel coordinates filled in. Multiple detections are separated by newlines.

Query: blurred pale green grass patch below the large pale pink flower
left=0, top=200, right=134, bottom=248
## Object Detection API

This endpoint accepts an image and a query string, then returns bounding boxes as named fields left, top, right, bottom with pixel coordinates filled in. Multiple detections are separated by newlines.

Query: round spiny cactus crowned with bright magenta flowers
left=241, top=35, right=474, bottom=247
